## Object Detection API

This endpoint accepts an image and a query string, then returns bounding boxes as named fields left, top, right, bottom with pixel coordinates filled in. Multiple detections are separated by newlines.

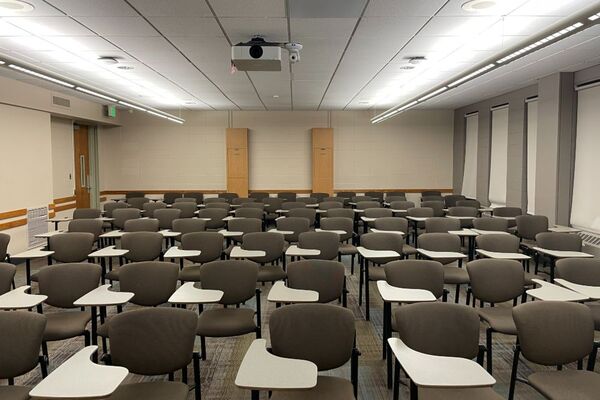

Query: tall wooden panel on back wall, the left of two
left=226, top=128, right=248, bottom=197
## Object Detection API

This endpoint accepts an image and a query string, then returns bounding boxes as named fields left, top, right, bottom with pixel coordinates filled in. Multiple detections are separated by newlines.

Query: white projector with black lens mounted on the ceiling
left=231, top=37, right=302, bottom=71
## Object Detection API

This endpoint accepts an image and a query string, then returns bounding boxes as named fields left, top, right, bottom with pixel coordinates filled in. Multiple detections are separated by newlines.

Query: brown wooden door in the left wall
left=73, top=125, right=90, bottom=208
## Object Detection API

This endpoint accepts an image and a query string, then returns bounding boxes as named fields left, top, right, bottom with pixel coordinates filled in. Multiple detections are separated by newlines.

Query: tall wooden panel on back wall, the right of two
left=312, top=128, right=333, bottom=194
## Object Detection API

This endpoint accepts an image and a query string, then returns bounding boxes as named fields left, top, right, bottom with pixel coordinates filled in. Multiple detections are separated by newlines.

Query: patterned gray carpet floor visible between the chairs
left=9, top=253, right=592, bottom=400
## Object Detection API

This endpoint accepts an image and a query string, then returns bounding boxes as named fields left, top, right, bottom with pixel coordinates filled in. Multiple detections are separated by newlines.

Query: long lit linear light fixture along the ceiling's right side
left=371, top=9, right=600, bottom=124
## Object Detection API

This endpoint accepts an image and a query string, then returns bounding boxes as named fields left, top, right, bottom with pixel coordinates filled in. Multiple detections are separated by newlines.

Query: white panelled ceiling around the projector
left=0, top=0, right=600, bottom=110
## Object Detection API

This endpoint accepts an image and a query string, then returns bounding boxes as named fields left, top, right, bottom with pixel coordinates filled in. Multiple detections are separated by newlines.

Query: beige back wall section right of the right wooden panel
left=331, top=110, right=454, bottom=189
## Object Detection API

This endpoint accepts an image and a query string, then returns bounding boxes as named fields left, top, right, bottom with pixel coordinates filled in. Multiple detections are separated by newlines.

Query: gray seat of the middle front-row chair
left=271, top=375, right=354, bottom=400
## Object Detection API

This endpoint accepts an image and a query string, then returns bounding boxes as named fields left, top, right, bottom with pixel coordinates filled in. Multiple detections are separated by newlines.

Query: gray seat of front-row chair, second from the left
left=108, top=381, right=189, bottom=400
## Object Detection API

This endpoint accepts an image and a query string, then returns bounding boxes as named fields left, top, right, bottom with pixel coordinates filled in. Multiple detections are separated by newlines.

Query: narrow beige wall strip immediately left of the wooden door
left=50, top=117, right=75, bottom=199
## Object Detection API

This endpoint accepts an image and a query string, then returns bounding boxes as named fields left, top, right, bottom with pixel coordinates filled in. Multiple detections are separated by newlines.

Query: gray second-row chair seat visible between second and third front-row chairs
left=196, top=308, right=256, bottom=337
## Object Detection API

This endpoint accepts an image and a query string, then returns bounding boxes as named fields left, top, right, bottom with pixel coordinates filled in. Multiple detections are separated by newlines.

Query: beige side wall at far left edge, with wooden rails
left=0, top=105, right=53, bottom=253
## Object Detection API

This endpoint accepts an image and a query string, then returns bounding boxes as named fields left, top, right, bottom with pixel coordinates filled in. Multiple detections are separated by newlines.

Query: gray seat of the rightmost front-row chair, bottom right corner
left=527, top=369, right=600, bottom=400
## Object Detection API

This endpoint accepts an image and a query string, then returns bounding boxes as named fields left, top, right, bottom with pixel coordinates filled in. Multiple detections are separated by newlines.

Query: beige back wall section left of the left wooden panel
left=98, top=108, right=227, bottom=190
